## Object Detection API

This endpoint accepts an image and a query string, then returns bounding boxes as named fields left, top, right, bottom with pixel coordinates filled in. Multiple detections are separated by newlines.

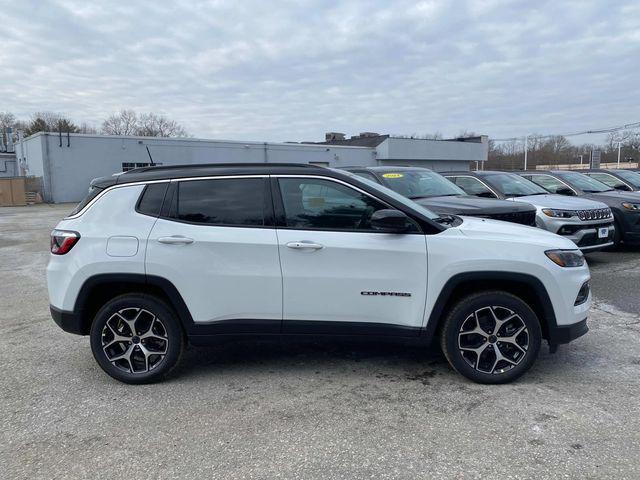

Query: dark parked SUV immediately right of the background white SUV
left=521, top=170, right=640, bottom=246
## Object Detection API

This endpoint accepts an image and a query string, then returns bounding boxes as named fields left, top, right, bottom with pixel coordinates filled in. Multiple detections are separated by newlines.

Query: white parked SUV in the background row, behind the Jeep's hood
left=443, top=171, right=615, bottom=252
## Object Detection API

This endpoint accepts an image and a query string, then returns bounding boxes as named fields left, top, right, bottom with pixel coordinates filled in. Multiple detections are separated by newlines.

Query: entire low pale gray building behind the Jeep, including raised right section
left=15, top=132, right=488, bottom=203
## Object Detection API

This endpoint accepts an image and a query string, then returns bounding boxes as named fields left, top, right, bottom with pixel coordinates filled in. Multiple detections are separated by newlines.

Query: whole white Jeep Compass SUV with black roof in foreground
left=47, top=164, right=591, bottom=383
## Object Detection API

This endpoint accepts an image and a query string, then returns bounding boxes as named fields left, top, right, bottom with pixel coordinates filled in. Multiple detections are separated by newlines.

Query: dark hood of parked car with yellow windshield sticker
left=414, top=195, right=535, bottom=215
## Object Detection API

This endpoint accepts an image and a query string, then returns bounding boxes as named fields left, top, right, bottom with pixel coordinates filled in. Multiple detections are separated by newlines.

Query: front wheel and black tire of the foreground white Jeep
left=440, top=291, right=542, bottom=384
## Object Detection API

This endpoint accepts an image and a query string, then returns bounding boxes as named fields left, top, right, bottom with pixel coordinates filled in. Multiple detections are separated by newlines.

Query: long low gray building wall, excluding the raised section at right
left=18, top=133, right=375, bottom=203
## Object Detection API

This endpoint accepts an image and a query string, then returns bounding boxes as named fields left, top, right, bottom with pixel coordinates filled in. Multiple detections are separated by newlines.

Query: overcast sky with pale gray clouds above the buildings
left=0, top=0, right=640, bottom=141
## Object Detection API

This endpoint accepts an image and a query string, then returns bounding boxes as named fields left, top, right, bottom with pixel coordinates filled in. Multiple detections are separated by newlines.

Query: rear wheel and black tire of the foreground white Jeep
left=90, top=294, right=185, bottom=384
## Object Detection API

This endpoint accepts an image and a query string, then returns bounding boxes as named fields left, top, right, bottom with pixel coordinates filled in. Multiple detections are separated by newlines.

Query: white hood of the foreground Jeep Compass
left=453, top=217, right=578, bottom=250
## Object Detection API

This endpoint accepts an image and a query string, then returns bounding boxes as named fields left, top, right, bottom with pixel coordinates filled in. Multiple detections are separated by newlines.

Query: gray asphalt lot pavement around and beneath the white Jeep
left=0, top=205, right=640, bottom=480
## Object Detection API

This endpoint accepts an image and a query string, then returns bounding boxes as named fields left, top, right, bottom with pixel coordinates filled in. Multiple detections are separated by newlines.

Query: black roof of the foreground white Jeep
left=113, top=163, right=334, bottom=184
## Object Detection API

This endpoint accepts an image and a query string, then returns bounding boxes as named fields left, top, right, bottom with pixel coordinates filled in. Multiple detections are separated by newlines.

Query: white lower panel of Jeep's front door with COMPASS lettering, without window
left=278, top=230, right=427, bottom=332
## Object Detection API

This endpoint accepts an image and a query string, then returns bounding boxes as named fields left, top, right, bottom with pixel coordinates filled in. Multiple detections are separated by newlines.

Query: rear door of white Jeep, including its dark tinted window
left=146, top=177, right=282, bottom=333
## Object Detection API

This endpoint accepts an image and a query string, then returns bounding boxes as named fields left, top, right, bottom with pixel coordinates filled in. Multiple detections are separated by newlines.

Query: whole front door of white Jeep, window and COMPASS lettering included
left=276, top=178, right=427, bottom=334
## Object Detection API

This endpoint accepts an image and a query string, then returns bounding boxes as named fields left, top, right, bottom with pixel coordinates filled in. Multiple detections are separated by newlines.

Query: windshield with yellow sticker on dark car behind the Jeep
left=381, top=169, right=466, bottom=198
